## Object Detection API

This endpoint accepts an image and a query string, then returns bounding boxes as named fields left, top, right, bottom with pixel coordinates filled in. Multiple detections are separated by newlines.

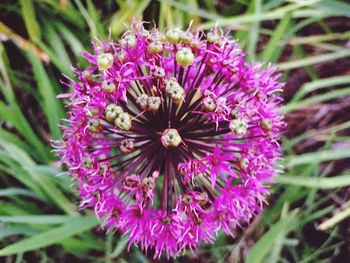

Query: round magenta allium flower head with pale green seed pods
left=55, top=22, right=284, bottom=257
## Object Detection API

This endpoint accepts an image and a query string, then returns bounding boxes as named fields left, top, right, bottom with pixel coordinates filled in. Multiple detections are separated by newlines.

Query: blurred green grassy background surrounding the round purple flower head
left=0, top=0, right=350, bottom=263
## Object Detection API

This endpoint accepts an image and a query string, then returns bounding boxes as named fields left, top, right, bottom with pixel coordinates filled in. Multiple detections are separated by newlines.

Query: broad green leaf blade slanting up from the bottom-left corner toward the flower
left=0, top=216, right=98, bottom=256
